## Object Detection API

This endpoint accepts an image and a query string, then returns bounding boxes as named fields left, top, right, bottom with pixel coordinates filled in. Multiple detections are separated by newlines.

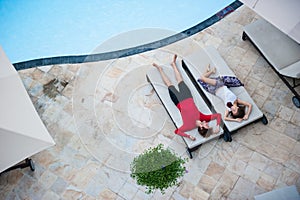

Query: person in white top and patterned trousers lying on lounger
left=198, top=65, right=252, bottom=122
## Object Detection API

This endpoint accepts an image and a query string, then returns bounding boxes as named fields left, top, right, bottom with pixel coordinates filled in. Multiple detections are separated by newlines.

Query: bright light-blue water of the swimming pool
left=0, top=0, right=233, bottom=63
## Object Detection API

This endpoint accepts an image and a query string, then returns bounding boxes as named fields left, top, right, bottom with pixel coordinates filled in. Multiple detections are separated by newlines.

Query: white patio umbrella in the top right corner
left=240, top=0, right=300, bottom=44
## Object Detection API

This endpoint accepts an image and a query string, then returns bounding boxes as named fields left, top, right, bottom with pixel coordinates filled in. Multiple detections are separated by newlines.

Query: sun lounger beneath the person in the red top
left=146, top=58, right=223, bottom=158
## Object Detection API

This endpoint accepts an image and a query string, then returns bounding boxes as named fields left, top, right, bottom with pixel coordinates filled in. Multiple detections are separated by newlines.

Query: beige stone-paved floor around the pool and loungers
left=0, top=6, right=300, bottom=200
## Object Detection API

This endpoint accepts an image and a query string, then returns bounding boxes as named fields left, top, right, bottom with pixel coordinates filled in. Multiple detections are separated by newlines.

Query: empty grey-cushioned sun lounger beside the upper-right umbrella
left=242, top=19, right=300, bottom=108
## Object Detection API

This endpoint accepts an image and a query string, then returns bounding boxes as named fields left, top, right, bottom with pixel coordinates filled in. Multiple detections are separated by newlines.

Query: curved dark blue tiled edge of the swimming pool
left=13, top=0, right=243, bottom=70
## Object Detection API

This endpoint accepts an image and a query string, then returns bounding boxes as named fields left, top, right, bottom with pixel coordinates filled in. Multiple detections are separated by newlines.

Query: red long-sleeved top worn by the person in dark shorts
left=175, top=98, right=221, bottom=137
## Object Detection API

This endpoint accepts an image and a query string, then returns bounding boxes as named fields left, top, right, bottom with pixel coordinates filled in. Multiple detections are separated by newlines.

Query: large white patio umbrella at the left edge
left=0, top=46, right=55, bottom=172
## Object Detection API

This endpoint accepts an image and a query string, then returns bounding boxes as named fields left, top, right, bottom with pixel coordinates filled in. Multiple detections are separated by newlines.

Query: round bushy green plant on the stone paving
left=130, top=144, right=187, bottom=194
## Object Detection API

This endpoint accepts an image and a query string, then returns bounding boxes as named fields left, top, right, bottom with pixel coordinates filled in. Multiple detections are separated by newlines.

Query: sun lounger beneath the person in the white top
left=183, top=47, right=268, bottom=133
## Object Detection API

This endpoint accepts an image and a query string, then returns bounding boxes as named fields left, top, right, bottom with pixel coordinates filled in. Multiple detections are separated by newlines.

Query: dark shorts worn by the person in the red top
left=168, top=81, right=193, bottom=106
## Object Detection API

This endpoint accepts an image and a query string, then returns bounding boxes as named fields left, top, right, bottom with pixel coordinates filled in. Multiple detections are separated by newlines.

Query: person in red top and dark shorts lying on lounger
left=153, top=55, right=221, bottom=140
